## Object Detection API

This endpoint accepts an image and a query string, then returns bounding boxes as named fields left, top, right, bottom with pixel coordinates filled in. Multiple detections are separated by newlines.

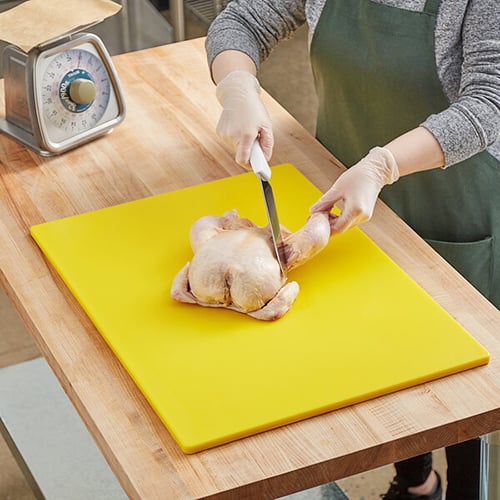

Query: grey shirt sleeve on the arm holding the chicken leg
left=422, top=0, right=500, bottom=167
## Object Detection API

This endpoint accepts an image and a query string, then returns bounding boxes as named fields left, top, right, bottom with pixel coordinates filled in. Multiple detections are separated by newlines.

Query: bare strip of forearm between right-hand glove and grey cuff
left=384, top=127, right=445, bottom=176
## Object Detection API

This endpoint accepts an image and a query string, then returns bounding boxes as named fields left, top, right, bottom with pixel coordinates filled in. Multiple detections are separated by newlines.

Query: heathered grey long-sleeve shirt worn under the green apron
left=206, top=0, right=500, bottom=166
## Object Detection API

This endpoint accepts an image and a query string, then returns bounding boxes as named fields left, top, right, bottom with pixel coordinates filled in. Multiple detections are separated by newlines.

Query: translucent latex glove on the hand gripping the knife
left=216, top=70, right=274, bottom=168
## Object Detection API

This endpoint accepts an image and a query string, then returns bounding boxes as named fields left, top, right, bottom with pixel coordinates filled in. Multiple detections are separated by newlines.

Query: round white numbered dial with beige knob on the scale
left=42, top=49, right=111, bottom=134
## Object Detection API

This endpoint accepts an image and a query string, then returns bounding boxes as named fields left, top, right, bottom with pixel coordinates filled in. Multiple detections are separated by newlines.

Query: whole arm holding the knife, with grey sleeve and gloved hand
left=206, top=0, right=305, bottom=167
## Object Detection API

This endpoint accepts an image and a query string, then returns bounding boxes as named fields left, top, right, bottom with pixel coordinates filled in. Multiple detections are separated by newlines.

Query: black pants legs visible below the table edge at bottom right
left=395, top=438, right=481, bottom=500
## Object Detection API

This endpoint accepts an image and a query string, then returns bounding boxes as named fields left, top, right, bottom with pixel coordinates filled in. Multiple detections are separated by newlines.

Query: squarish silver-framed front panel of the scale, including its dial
left=34, top=38, right=123, bottom=149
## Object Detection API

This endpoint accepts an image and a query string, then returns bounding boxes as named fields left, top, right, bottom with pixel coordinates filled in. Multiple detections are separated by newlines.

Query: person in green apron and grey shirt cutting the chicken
left=206, top=0, right=500, bottom=500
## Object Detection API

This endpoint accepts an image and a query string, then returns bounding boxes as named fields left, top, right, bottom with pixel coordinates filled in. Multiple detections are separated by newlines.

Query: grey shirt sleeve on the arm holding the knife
left=205, top=0, right=305, bottom=73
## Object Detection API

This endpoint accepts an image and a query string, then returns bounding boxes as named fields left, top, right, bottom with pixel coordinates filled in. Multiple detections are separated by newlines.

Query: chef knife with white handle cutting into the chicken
left=250, top=140, right=286, bottom=279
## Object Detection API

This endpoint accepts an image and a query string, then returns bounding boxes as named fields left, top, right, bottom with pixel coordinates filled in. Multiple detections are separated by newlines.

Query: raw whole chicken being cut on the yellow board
left=170, top=210, right=335, bottom=320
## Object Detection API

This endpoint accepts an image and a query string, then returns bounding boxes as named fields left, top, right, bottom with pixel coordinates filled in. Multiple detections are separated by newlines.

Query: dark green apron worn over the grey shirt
left=311, top=0, right=500, bottom=308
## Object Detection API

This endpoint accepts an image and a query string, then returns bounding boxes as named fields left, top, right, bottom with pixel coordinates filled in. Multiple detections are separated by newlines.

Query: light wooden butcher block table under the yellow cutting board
left=0, top=39, right=500, bottom=499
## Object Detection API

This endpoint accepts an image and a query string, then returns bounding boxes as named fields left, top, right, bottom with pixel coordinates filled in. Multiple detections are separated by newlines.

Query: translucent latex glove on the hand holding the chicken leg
left=310, top=147, right=399, bottom=234
